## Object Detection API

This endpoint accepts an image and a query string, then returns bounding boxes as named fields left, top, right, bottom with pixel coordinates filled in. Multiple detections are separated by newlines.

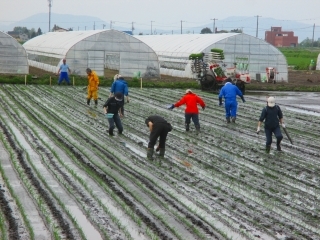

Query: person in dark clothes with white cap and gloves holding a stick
left=257, top=97, right=285, bottom=153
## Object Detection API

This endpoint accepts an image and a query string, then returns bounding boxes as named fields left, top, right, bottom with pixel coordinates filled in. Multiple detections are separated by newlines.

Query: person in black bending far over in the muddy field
left=145, top=115, right=172, bottom=160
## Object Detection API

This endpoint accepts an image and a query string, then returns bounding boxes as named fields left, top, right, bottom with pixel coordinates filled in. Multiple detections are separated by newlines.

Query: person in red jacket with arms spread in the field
left=169, top=89, right=206, bottom=132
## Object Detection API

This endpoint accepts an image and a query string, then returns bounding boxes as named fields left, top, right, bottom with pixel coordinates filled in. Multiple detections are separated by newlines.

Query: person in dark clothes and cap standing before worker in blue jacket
left=103, top=92, right=123, bottom=136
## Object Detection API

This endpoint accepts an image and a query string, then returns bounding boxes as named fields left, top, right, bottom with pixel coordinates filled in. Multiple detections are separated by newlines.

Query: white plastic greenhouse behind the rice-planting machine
left=135, top=33, right=288, bottom=82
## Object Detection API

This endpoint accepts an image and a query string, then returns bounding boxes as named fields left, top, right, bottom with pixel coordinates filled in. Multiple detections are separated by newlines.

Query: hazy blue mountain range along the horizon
left=0, top=13, right=320, bottom=42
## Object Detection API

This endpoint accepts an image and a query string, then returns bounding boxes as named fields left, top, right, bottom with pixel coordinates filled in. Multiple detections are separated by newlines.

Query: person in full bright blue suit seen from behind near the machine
left=219, top=78, right=246, bottom=123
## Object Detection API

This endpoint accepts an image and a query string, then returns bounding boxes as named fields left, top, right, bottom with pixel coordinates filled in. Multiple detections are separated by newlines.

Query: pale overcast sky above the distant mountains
left=0, top=0, right=320, bottom=29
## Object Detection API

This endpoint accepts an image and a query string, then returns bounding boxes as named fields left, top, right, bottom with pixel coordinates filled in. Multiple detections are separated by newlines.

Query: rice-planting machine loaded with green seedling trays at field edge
left=189, top=49, right=251, bottom=94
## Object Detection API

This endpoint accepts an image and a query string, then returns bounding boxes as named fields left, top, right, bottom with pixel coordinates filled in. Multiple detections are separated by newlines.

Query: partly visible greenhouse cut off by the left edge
left=0, top=32, right=29, bottom=74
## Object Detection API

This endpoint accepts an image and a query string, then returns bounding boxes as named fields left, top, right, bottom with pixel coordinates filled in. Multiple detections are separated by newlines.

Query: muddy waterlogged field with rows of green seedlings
left=0, top=85, right=320, bottom=240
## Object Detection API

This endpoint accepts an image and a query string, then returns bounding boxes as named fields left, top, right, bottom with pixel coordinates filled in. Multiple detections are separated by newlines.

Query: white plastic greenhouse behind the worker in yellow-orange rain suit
left=23, top=30, right=160, bottom=78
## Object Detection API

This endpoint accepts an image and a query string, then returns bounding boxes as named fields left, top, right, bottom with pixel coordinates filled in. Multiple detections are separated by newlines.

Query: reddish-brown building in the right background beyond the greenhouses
left=264, top=27, right=298, bottom=47
